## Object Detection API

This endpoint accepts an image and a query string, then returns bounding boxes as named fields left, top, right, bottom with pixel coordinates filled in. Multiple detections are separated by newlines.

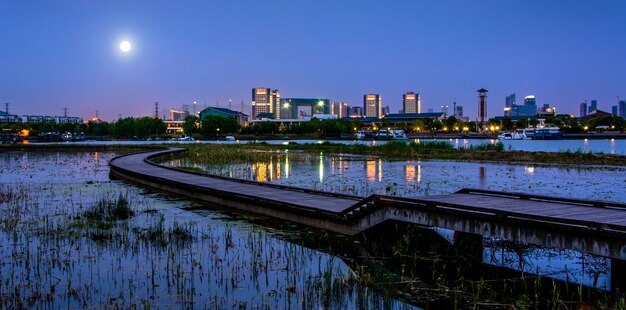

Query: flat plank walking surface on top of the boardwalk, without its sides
left=112, top=151, right=626, bottom=235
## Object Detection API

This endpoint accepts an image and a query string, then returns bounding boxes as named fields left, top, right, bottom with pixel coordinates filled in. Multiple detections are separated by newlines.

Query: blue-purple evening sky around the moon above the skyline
left=0, top=0, right=626, bottom=121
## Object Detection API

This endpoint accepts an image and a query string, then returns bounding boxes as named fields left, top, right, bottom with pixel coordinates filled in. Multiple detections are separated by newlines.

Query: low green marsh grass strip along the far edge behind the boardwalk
left=155, top=141, right=626, bottom=166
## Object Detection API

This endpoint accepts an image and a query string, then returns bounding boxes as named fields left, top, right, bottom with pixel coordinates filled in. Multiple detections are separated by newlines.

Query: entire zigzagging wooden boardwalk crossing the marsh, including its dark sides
left=110, top=149, right=626, bottom=259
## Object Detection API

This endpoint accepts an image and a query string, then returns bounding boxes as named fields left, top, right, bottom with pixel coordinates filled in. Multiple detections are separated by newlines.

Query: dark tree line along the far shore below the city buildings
left=0, top=115, right=626, bottom=139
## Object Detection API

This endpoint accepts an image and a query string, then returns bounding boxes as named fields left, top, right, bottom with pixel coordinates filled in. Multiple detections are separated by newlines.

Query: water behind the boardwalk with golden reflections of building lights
left=167, top=151, right=626, bottom=202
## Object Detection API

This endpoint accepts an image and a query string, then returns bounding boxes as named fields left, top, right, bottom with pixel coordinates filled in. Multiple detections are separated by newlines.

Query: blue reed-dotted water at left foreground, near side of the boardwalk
left=0, top=152, right=412, bottom=309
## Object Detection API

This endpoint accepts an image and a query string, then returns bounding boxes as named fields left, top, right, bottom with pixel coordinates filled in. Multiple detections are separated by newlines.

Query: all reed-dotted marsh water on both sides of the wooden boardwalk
left=0, top=151, right=626, bottom=309
